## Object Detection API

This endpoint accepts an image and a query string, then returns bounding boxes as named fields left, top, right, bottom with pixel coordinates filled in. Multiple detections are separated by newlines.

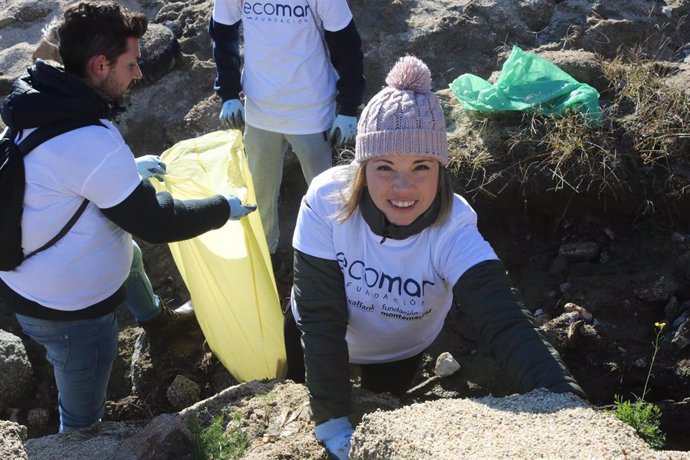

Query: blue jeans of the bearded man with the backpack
left=15, top=313, right=118, bottom=432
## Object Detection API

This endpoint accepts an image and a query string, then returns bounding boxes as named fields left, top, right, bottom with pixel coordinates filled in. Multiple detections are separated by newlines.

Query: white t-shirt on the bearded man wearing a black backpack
left=0, top=120, right=141, bottom=311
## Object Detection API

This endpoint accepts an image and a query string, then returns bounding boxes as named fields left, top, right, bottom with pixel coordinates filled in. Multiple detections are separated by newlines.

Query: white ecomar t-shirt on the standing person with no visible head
left=213, top=0, right=352, bottom=134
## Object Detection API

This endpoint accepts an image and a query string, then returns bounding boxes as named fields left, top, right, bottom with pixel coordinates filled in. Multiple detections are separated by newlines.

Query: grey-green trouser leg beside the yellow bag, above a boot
left=125, top=240, right=161, bottom=323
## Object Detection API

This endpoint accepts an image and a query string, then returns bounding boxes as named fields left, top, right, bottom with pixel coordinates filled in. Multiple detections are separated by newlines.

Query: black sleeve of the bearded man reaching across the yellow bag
left=101, top=180, right=230, bottom=243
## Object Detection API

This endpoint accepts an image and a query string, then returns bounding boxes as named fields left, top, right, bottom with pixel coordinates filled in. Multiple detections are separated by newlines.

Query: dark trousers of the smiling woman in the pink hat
left=283, top=307, right=422, bottom=396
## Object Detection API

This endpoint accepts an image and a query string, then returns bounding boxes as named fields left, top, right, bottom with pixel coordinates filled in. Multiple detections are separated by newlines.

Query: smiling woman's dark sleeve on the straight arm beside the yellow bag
left=293, top=250, right=352, bottom=423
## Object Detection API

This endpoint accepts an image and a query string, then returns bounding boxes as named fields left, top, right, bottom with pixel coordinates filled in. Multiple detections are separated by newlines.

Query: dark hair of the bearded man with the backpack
left=58, top=1, right=148, bottom=77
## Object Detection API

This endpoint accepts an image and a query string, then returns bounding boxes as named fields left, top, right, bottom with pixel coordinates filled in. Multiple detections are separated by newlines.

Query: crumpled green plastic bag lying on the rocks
left=450, top=46, right=603, bottom=126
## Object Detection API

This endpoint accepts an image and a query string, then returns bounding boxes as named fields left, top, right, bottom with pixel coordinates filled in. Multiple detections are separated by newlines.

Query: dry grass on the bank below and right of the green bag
left=450, top=46, right=690, bottom=203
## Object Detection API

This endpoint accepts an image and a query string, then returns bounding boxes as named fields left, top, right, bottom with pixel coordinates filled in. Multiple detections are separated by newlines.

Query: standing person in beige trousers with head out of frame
left=209, top=0, right=365, bottom=273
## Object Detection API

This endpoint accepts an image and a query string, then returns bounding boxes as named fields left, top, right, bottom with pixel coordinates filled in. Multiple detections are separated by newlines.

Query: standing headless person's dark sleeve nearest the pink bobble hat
left=325, top=19, right=365, bottom=117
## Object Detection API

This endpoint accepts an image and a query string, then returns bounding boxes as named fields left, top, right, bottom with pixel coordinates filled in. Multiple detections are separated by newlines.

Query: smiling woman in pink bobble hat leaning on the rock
left=285, top=56, right=585, bottom=459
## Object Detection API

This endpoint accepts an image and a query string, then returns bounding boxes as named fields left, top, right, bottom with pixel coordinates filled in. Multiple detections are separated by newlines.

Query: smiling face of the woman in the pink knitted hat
left=365, top=155, right=439, bottom=225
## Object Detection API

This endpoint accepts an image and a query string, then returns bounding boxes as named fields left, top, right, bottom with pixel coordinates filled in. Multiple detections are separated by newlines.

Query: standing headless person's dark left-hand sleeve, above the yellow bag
left=208, top=18, right=242, bottom=102
